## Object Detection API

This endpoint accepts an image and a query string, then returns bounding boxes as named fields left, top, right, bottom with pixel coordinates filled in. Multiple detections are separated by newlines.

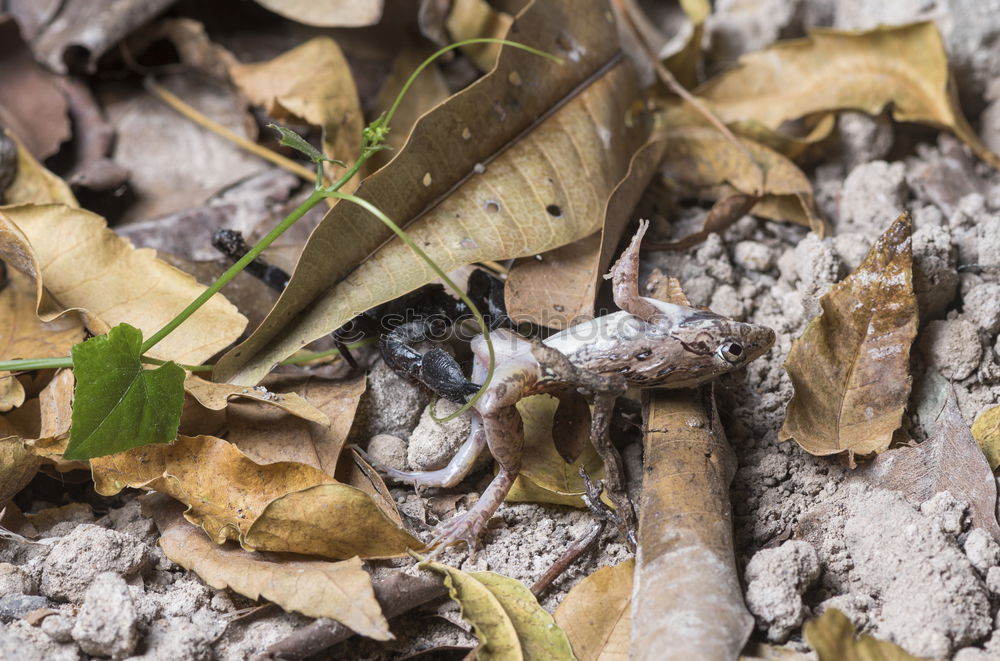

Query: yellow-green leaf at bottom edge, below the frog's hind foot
left=420, top=562, right=574, bottom=661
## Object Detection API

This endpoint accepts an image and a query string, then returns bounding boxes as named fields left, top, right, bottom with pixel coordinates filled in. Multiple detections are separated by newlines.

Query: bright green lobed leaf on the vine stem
left=63, top=324, right=184, bottom=459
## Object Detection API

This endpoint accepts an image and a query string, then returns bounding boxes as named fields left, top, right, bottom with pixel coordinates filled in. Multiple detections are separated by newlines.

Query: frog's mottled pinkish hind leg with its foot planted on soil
left=430, top=381, right=524, bottom=551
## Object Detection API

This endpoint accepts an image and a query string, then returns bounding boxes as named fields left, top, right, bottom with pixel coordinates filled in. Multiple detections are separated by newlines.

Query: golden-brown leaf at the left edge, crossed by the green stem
left=0, top=269, right=86, bottom=411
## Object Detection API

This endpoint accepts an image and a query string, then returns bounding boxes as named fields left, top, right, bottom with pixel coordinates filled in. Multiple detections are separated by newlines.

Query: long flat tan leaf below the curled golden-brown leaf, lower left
left=142, top=494, right=393, bottom=640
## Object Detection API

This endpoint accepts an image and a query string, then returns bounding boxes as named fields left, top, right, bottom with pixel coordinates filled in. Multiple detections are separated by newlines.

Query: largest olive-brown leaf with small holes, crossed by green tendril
left=216, top=0, right=646, bottom=384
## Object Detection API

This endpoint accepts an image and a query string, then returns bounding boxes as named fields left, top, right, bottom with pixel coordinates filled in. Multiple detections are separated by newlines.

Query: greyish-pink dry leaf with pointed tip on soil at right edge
left=850, top=370, right=1000, bottom=541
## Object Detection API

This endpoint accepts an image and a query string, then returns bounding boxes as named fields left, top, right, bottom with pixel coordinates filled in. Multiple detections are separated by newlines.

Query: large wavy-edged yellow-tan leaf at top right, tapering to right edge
left=696, top=22, right=1000, bottom=167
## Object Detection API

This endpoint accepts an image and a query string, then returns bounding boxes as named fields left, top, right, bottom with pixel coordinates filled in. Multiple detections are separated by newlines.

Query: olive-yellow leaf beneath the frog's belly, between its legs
left=507, top=395, right=604, bottom=507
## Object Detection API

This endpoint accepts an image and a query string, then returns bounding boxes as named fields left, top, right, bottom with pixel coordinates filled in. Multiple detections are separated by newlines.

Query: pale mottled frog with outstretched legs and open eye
left=368, top=221, right=774, bottom=549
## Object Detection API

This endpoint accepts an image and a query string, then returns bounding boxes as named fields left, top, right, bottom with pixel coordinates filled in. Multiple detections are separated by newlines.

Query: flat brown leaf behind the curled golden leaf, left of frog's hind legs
left=226, top=374, right=366, bottom=476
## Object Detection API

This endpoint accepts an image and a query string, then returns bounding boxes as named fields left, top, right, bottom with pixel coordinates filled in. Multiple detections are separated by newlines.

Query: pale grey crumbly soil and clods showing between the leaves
left=7, top=0, right=1000, bottom=661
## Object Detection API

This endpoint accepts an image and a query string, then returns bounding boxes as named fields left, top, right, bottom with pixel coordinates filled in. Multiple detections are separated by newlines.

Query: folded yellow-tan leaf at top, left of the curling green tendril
left=230, top=37, right=364, bottom=170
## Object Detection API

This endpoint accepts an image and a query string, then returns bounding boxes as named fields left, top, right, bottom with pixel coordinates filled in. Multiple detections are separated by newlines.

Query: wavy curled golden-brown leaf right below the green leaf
left=91, top=436, right=422, bottom=559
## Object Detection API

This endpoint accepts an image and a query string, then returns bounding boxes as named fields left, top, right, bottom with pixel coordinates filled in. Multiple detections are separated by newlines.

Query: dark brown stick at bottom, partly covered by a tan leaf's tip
left=253, top=571, right=448, bottom=661
